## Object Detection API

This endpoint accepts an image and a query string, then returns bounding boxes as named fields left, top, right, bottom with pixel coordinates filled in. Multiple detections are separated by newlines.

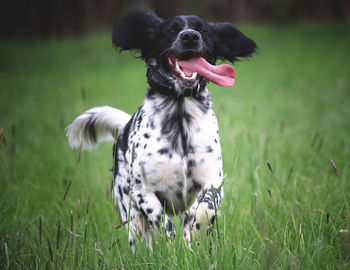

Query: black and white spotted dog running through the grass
left=67, top=10, right=256, bottom=250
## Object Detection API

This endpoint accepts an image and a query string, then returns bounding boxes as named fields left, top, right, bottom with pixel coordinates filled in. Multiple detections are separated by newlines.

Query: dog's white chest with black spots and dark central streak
left=129, top=92, right=222, bottom=213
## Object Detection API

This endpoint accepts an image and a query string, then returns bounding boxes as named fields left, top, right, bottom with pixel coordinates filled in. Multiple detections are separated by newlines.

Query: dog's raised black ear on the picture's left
left=112, top=10, right=162, bottom=59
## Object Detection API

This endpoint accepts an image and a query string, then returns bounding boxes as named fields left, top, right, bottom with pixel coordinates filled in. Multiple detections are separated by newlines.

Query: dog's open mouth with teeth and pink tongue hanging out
left=168, top=51, right=236, bottom=87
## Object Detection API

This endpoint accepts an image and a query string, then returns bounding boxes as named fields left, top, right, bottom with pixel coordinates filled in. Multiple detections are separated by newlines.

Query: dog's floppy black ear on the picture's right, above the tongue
left=209, top=23, right=256, bottom=62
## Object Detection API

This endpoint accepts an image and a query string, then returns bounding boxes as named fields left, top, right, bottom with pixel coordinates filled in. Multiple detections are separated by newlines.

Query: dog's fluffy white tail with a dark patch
left=67, top=106, right=131, bottom=150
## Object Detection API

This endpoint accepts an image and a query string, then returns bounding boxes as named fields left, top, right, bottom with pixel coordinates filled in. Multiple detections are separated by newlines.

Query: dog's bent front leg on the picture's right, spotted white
left=190, top=184, right=224, bottom=235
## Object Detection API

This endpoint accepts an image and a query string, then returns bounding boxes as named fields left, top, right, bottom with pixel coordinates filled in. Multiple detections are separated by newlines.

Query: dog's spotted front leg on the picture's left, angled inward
left=135, top=191, right=175, bottom=238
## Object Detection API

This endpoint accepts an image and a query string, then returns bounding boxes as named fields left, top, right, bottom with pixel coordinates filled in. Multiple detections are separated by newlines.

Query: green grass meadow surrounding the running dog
left=0, top=24, right=350, bottom=269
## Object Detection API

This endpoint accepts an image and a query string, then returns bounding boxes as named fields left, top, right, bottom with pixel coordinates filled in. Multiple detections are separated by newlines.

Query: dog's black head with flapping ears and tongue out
left=112, top=10, right=256, bottom=94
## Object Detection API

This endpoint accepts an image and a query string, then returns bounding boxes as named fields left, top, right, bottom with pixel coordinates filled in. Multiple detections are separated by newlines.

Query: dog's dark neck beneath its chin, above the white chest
left=147, top=59, right=208, bottom=99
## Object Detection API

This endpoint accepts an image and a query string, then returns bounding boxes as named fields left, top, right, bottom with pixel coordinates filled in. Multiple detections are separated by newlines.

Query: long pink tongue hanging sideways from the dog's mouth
left=179, top=57, right=236, bottom=87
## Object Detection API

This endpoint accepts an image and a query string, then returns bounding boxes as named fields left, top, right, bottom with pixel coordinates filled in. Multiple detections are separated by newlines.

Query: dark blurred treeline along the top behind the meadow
left=0, top=0, right=350, bottom=38
